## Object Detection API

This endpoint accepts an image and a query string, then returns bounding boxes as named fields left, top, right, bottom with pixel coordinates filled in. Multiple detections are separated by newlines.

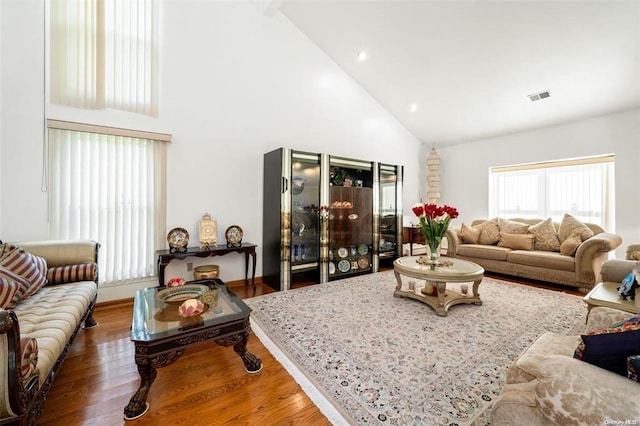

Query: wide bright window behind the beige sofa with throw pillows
left=489, top=155, right=615, bottom=231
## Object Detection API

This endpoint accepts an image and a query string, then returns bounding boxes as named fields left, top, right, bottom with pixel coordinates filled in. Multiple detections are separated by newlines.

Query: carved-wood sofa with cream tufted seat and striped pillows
left=0, top=241, right=99, bottom=424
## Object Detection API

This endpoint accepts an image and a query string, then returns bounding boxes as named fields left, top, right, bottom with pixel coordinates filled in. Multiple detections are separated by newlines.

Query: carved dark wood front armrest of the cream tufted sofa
left=0, top=309, right=38, bottom=419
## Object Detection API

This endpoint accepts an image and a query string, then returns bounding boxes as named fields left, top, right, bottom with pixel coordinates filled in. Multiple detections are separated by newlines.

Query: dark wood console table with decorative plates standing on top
left=156, top=243, right=257, bottom=290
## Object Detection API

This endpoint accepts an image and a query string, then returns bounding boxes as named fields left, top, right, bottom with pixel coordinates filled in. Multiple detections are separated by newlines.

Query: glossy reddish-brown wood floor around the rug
left=38, top=277, right=579, bottom=426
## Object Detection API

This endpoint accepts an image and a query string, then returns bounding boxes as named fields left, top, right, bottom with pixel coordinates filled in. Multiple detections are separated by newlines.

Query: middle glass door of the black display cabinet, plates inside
left=329, top=158, right=373, bottom=280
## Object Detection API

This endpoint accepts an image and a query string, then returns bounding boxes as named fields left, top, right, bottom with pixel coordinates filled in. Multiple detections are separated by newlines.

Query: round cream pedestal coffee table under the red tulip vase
left=393, top=256, right=484, bottom=317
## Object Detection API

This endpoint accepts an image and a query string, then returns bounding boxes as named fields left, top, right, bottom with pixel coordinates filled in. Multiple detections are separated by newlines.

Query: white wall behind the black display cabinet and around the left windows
left=0, top=0, right=422, bottom=301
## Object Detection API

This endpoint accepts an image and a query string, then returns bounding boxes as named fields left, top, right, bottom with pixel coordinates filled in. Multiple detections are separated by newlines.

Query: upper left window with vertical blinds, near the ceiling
left=49, top=0, right=158, bottom=116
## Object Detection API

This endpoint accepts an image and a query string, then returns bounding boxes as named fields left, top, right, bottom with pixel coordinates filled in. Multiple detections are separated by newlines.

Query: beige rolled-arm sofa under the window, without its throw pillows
left=446, top=218, right=622, bottom=293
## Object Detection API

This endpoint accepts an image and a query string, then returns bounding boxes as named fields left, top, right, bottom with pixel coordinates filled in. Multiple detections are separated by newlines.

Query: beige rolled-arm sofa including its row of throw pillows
left=446, top=215, right=622, bottom=293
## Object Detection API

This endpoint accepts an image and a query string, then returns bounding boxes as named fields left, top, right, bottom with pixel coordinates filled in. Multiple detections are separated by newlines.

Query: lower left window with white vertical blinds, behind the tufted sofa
left=48, top=120, right=170, bottom=282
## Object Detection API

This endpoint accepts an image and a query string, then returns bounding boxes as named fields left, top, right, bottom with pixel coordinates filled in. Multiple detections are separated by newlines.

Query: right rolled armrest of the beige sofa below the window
left=576, top=232, right=622, bottom=284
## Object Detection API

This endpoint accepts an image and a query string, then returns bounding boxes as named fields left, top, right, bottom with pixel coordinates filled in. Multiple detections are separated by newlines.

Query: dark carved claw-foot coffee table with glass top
left=124, top=279, right=262, bottom=420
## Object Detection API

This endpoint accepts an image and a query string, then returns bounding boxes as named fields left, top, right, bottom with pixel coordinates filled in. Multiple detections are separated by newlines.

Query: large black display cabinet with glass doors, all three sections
left=262, top=148, right=402, bottom=290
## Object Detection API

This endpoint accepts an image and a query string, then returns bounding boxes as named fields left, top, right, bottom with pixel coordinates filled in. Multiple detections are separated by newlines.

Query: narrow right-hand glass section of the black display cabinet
left=377, top=164, right=403, bottom=261
